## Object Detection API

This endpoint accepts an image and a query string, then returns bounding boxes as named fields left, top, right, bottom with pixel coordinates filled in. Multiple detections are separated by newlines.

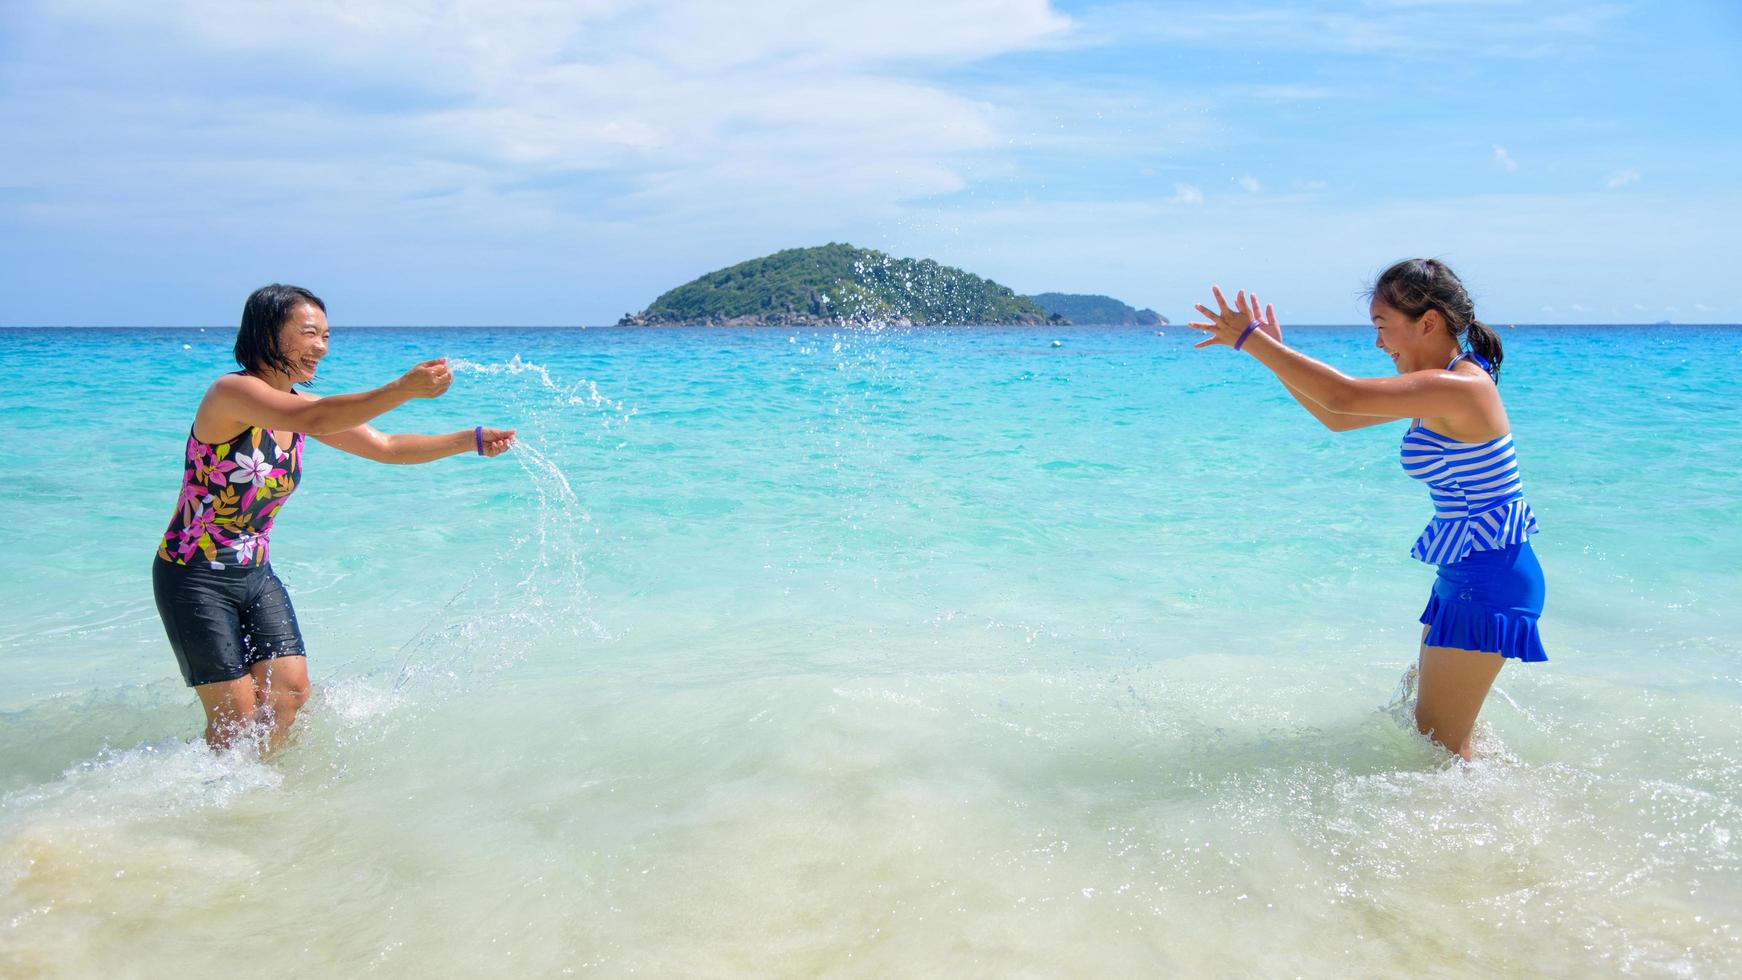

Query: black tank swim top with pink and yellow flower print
left=157, top=425, right=303, bottom=567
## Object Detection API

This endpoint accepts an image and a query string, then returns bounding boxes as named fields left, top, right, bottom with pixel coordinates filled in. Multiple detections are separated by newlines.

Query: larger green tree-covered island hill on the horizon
left=618, top=244, right=1063, bottom=327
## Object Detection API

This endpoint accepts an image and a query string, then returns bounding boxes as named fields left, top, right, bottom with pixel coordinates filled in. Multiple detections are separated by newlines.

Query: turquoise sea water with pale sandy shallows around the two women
left=0, top=327, right=1742, bottom=977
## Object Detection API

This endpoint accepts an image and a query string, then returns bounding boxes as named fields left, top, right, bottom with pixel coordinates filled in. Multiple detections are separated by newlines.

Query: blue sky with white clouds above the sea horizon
left=0, top=0, right=1742, bottom=326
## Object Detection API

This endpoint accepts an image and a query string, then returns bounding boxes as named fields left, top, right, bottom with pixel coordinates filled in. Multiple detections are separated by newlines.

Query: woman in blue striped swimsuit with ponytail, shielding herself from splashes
left=1192, top=259, right=1547, bottom=759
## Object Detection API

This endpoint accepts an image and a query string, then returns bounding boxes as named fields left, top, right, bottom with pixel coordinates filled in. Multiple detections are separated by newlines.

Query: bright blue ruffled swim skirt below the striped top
left=1421, top=541, right=1549, bottom=663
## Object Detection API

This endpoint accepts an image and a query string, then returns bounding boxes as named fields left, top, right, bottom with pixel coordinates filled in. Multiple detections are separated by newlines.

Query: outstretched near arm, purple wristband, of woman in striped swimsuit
left=1190, top=287, right=1495, bottom=420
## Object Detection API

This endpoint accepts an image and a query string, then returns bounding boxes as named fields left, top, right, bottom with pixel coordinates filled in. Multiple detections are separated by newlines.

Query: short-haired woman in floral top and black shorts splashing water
left=152, top=284, right=514, bottom=752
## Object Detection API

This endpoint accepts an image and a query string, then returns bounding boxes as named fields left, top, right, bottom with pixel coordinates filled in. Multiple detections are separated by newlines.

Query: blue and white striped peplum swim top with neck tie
left=1402, top=353, right=1536, bottom=566
